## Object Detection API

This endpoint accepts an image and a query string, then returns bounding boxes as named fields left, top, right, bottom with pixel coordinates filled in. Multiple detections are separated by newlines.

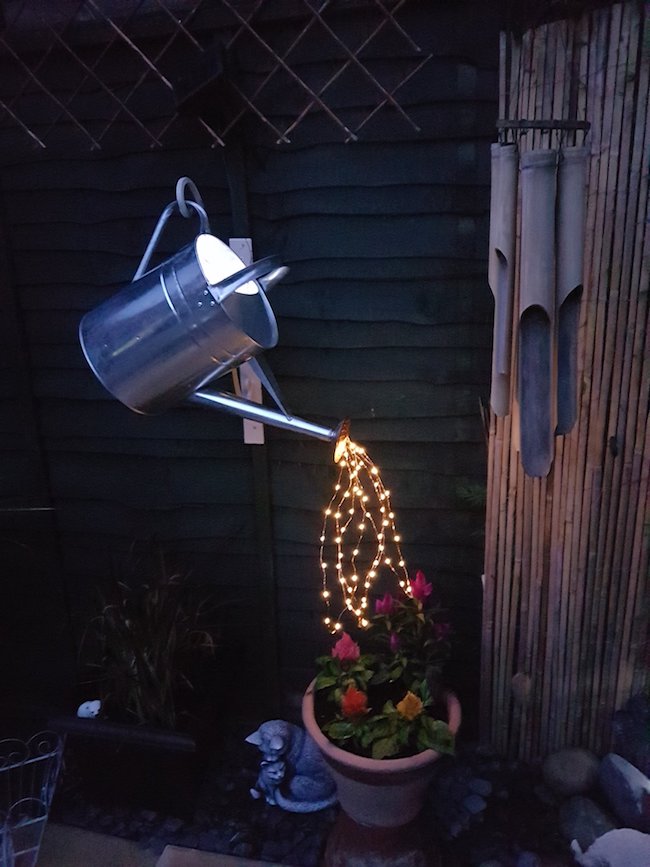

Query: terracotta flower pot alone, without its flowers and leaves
left=302, top=681, right=461, bottom=828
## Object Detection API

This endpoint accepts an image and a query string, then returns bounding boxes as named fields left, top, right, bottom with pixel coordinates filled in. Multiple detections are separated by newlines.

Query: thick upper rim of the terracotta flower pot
left=302, top=678, right=462, bottom=773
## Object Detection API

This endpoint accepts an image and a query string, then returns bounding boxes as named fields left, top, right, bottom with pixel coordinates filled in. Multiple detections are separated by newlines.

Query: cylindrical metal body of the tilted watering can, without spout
left=79, top=236, right=278, bottom=414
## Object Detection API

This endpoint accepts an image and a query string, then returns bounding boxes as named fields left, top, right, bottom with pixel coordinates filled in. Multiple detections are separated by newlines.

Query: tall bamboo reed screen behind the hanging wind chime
left=481, top=2, right=650, bottom=758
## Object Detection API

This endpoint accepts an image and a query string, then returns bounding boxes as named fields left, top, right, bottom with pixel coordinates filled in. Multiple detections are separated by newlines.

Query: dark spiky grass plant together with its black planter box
left=50, top=551, right=217, bottom=812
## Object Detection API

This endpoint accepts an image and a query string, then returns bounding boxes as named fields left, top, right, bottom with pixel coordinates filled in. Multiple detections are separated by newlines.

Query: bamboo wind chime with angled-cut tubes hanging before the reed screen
left=488, top=128, right=588, bottom=476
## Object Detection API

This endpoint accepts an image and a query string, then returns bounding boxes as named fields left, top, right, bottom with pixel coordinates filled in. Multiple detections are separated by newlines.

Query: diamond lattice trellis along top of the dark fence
left=0, top=0, right=429, bottom=149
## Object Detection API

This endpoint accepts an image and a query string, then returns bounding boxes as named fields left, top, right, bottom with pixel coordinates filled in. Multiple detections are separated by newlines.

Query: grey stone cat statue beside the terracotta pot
left=246, top=720, right=336, bottom=813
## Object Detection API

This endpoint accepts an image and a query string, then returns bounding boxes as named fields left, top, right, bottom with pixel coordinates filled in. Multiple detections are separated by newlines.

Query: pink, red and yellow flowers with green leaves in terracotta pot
left=314, top=572, right=454, bottom=759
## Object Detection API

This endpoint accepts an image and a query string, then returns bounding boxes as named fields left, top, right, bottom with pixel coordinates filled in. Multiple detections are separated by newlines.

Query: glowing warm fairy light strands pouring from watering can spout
left=319, top=431, right=409, bottom=633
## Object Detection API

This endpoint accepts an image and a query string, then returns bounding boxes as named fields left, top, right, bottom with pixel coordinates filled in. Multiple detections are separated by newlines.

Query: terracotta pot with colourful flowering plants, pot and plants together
left=302, top=572, right=461, bottom=828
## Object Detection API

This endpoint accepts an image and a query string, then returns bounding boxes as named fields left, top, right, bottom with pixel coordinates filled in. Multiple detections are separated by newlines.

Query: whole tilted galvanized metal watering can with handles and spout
left=79, top=181, right=339, bottom=441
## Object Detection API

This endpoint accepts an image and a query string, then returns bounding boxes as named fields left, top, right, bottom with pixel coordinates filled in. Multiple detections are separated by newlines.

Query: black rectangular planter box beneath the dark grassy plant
left=48, top=716, right=203, bottom=819
